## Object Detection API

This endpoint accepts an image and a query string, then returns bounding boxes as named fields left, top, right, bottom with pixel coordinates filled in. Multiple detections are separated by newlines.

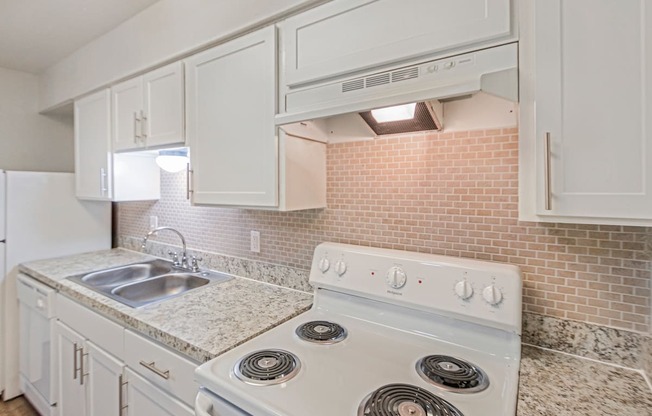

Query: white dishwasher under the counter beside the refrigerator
left=17, top=274, right=56, bottom=416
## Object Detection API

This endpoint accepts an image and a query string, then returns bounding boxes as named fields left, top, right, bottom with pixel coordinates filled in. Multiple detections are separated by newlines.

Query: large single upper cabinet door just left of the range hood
left=187, top=27, right=278, bottom=207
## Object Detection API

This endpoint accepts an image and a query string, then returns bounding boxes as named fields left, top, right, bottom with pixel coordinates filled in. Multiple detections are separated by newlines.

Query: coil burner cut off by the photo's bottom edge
left=358, top=384, right=464, bottom=416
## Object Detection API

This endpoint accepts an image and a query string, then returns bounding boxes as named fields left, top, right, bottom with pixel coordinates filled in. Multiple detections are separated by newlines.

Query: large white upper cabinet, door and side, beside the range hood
left=186, top=27, right=326, bottom=211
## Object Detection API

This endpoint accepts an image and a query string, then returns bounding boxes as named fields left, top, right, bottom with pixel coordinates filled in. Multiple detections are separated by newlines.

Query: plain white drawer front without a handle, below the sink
left=57, top=295, right=124, bottom=360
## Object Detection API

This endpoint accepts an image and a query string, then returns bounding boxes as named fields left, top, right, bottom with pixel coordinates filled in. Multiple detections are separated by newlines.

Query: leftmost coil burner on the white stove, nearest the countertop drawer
left=233, top=350, right=301, bottom=386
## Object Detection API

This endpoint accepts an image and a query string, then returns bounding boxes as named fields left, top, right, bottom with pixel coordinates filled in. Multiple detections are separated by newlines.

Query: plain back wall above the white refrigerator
left=0, top=68, right=74, bottom=172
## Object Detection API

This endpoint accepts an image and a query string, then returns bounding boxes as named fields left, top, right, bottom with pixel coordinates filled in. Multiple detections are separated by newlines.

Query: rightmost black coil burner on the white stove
left=416, top=355, right=489, bottom=393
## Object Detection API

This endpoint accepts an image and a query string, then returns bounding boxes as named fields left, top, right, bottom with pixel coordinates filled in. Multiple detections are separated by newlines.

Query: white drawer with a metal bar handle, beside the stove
left=125, top=330, right=199, bottom=407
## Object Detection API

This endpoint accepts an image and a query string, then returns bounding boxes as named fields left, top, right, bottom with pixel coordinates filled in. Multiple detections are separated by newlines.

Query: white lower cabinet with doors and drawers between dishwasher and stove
left=54, top=296, right=199, bottom=416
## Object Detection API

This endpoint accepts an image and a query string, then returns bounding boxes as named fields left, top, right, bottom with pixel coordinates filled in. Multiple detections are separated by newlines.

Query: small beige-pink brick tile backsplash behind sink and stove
left=117, top=128, right=652, bottom=331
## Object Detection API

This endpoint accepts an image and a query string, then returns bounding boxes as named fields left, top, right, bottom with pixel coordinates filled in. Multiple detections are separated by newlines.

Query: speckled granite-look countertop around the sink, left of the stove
left=19, top=249, right=312, bottom=362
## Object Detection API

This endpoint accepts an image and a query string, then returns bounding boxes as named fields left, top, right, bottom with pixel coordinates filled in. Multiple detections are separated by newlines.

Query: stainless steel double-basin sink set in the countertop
left=69, top=259, right=232, bottom=308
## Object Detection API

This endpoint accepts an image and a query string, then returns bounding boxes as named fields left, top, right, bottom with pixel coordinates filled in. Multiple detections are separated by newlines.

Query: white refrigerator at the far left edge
left=0, top=170, right=111, bottom=400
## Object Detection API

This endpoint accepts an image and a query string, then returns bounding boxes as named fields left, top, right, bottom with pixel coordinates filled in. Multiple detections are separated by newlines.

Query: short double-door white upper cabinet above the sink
left=111, top=62, right=185, bottom=151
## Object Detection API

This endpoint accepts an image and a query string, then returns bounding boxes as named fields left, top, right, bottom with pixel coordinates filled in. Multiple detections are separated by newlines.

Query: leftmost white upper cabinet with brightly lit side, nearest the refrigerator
left=74, top=89, right=161, bottom=201
